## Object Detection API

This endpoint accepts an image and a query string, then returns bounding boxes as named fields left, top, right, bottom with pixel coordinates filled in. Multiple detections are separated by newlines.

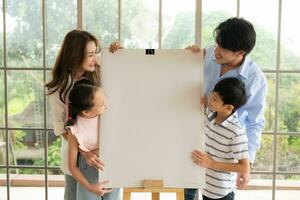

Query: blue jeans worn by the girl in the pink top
left=77, top=154, right=121, bottom=200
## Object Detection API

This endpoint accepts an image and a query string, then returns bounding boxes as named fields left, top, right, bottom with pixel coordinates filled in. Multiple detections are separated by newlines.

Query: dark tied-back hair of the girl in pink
left=66, top=79, right=99, bottom=126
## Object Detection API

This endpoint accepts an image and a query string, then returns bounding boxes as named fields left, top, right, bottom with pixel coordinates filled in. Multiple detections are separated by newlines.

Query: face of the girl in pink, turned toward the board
left=83, top=88, right=107, bottom=117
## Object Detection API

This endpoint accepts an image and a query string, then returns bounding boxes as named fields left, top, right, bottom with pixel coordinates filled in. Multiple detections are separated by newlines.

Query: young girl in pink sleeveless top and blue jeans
left=67, top=79, right=119, bottom=200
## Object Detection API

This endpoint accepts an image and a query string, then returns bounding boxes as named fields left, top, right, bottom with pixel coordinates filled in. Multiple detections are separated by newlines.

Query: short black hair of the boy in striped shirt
left=214, top=78, right=246, bottom=112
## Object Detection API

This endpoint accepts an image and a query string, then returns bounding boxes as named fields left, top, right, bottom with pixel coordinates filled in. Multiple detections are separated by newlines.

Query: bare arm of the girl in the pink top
left=68, top=133, right=111, bottom=196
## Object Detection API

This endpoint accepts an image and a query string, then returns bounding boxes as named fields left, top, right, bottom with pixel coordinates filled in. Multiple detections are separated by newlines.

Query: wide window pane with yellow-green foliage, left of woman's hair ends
left=7, top=70, right=44, bottom=128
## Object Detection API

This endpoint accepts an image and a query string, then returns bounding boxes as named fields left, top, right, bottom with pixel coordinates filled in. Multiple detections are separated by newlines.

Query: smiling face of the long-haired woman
left=81, top=41, right=98, bottom=72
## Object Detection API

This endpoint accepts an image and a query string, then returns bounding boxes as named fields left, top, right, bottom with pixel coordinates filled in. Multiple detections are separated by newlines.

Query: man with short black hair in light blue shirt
left=185, top=18, right=267, bottom=200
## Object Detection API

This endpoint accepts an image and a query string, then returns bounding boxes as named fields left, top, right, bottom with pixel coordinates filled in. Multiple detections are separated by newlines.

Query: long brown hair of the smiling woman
left=46, top=30, right=100, bottom=102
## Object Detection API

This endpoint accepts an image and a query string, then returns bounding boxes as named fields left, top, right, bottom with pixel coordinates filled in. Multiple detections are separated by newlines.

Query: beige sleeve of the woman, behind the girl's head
left=49, top=91, right=66, bottom=136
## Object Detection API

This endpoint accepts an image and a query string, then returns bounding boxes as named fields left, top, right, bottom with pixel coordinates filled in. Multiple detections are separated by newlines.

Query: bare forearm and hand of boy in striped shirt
left=192, top=150, right=250, bottom=173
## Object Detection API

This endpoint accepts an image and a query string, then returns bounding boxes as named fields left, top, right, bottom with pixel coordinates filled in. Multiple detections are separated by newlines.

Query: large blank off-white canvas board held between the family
left=100, top=49, right=205, bottom=188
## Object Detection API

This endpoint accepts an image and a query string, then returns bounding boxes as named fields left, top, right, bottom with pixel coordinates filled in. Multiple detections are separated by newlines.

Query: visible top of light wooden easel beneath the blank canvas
left=123, top=180, right=184, bottom=200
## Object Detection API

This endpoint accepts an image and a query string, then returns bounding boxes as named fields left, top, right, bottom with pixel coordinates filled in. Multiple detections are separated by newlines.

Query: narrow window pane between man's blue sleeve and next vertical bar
left=264, top=73, right=276, bottom=131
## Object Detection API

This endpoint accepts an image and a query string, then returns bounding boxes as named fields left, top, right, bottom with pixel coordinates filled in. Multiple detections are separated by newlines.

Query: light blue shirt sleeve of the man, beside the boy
left=241, top=72, right=267, bottom=163
